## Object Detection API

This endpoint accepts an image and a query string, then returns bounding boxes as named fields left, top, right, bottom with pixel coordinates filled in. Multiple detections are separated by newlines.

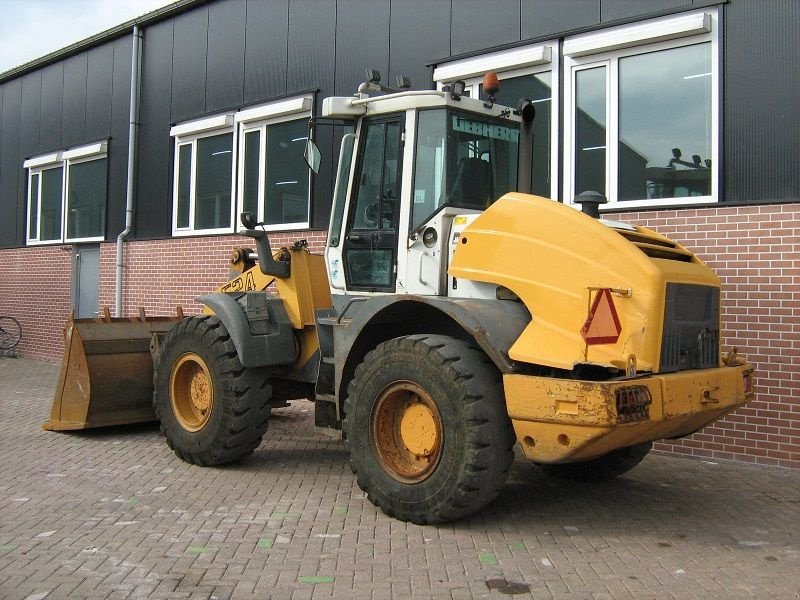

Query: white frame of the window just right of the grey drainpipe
left=169, top=114, right=237, bottom=237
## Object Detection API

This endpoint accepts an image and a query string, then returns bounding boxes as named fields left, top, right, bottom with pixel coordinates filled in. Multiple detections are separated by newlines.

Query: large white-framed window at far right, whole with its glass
left=564, top=12, right=719, bottom=208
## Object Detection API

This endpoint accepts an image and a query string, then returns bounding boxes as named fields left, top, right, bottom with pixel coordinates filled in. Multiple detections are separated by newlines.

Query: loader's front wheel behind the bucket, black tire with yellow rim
left=153, top=316, right=271, bottom=466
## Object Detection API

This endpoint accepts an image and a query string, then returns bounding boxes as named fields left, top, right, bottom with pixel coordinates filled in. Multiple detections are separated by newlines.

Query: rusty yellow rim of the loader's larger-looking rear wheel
left=371, top=381, right=444, bottom=483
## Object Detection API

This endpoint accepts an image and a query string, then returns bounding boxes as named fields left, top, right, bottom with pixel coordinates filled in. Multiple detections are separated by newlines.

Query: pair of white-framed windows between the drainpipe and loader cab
left=171, top=96, right=311, bottom=235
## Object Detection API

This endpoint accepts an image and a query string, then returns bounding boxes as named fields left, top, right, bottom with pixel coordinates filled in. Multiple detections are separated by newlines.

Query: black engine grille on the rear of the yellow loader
left=660, top=283, right=719, bottom=373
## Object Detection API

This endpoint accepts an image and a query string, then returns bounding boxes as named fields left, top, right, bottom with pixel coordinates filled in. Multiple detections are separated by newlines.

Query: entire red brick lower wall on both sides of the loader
left=0, top=204, right=800, bottom=468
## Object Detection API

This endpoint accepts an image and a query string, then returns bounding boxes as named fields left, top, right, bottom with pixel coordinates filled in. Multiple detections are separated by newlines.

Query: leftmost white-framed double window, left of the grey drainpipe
left=24, top=142, right=108, bottom=244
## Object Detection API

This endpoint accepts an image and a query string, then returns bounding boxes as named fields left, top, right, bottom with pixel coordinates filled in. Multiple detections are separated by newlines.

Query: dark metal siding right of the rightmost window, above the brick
left=723, top=0, right=800, bottom=202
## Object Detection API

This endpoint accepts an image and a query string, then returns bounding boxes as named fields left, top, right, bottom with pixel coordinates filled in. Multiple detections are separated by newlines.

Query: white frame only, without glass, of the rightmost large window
left=563, top=9, right=722, bottom=211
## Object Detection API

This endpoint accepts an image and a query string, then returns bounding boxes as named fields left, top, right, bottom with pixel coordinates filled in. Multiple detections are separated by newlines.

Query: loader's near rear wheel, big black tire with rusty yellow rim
left=343, top=335, right=515, bottom=524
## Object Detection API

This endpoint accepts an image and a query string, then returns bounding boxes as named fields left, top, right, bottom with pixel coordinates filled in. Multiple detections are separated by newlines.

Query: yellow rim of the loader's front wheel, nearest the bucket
left=169, top=352, right=214, bottom=431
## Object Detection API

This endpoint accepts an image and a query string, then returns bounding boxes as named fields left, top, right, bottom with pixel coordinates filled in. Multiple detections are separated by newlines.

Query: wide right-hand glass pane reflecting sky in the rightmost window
left=618, top=43, right=712, bottom=200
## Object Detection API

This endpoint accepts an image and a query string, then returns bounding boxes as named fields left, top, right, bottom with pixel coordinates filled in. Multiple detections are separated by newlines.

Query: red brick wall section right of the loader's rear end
left=612, top=204, right=800, bottom=468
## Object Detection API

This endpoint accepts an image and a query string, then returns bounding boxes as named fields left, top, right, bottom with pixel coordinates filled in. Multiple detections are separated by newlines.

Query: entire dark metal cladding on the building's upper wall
left=0, top=0, right=800, bottom=247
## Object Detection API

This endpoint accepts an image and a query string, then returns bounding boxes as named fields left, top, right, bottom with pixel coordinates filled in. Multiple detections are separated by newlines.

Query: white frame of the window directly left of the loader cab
left=235, top=96, right=314, bottom=231
